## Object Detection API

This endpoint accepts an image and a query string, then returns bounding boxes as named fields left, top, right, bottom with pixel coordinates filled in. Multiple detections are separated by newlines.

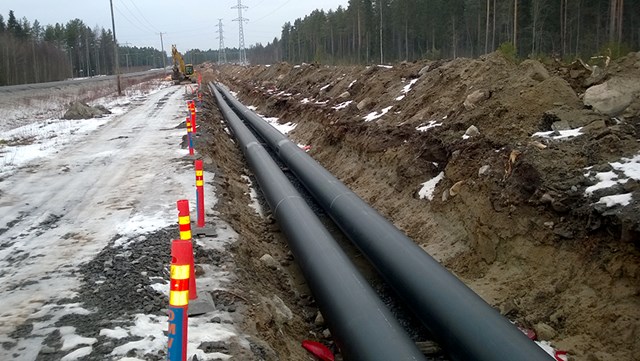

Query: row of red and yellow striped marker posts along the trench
left=167, top=96, right=205, bottom=361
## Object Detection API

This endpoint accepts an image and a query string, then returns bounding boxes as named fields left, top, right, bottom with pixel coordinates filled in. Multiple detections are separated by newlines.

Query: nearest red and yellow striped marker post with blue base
left=167, top=240, right=193, bottom=361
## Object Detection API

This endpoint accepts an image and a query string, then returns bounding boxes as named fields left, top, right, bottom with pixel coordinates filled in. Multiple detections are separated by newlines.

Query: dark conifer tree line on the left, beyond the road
left=0, top=11, right=170, bottom=86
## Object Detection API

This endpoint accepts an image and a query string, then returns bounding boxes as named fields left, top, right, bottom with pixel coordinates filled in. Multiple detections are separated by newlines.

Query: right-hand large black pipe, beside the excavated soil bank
left=219, top=86, right=553, bottom=361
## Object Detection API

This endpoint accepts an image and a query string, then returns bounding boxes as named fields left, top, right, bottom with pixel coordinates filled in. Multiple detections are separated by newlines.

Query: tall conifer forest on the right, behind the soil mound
left=248, top=0, right=640, bottom=64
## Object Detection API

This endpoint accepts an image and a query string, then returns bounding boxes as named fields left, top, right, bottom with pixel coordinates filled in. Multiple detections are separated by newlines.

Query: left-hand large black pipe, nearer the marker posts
left=210, top=86, right=425, bottom=361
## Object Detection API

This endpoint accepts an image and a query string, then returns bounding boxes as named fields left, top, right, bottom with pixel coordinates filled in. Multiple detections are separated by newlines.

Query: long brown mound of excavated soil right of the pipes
left=202, top=53, right=640, bottom=361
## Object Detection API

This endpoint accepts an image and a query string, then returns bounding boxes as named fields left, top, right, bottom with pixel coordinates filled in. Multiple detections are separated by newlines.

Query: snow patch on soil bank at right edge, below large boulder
left=584, top=154, right=640, bottom=208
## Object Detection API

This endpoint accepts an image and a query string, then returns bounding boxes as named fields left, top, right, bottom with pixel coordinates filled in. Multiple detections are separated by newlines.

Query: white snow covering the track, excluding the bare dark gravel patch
left=0, top=80, right=244, bottom=360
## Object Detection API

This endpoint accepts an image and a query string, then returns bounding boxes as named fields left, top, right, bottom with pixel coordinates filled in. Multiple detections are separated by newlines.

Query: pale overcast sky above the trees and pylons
left=0, top=0, right=348, bottom=53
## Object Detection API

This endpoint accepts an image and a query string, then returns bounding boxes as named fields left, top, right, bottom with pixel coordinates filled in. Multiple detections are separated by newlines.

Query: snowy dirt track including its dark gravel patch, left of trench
left=0, top=82, right=249, bottom=360
